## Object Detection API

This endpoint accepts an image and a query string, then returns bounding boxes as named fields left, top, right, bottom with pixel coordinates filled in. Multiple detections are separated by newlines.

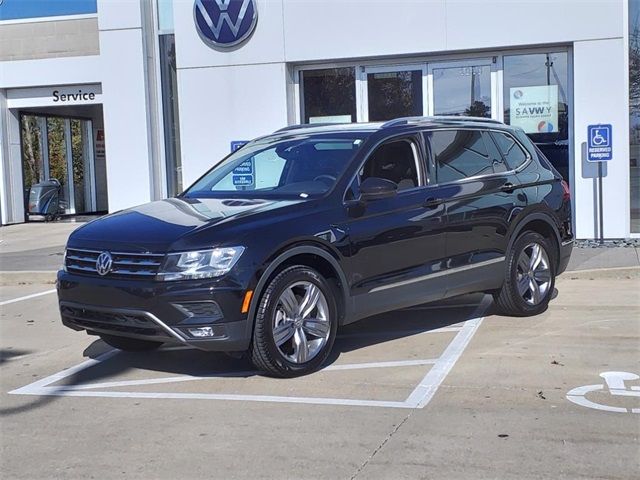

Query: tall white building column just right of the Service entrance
left=98, top=0, right=160, bottom=212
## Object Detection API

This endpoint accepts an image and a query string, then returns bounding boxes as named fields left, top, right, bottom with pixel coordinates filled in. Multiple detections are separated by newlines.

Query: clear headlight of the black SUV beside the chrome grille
left=158, top=247, right=244, bottom=281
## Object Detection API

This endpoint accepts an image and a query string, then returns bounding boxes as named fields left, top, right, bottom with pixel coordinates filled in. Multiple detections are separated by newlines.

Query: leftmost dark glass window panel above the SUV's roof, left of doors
left=300, top=67, right=357, bottom=123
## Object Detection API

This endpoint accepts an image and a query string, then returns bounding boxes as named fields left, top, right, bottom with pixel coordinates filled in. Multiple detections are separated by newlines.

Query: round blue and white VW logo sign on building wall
left=193, top=0, right=258, bottom=49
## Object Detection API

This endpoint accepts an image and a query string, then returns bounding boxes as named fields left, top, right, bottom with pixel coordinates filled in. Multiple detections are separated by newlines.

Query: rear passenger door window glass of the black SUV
left=426, top=130, right=507, bottom=183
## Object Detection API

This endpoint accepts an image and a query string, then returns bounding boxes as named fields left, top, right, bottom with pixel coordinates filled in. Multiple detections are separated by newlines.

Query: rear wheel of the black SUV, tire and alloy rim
left=494, top=231, right=556, bottom=317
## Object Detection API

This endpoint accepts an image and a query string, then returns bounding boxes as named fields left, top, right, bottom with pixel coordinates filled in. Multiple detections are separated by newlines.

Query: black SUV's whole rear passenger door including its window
left=425, top=128, right=526, bottom=296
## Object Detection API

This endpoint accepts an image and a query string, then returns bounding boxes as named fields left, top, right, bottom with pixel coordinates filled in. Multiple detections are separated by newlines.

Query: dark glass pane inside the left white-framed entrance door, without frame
left=367, top=70, right=422, bottom=122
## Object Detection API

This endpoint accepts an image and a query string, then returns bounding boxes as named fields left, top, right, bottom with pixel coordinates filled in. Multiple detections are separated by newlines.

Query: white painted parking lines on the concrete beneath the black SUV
left=9, top=297, right=489, bottom=408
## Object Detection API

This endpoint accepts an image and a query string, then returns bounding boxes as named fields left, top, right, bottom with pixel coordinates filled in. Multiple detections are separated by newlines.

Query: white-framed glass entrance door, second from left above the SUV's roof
left=362, top=65, right=426, bottom=122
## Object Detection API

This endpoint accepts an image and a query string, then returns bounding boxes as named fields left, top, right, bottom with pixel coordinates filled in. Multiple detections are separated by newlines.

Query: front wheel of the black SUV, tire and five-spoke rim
left=250, top=265, right=338, bottom=378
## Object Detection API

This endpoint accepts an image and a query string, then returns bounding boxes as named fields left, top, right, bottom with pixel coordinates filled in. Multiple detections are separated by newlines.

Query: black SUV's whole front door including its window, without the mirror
left=344, top=137, right=445, bottom=318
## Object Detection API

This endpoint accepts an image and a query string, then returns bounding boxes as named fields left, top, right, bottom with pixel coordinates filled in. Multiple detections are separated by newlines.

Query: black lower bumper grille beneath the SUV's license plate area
left=60, top=304, right=166, bottom=336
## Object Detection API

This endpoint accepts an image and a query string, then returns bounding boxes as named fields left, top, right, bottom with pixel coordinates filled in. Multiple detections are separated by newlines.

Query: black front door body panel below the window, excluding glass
left=346, top=187, right=445, bottom=318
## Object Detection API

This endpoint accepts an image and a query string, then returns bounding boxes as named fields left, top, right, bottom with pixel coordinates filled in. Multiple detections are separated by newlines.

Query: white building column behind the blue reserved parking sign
left=573, top=38, right=630, bottom=238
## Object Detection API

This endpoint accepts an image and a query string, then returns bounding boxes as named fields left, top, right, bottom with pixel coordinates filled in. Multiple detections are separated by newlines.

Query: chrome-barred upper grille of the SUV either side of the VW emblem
left=65, top=248, right=164, bottom=279
